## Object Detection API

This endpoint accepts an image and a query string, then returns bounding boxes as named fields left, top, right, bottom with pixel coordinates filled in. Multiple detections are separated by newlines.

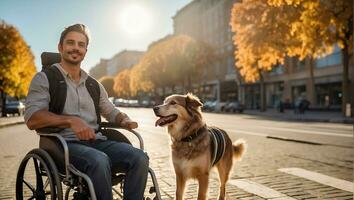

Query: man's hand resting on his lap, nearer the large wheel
left=70, top=116, right=96, bottom=140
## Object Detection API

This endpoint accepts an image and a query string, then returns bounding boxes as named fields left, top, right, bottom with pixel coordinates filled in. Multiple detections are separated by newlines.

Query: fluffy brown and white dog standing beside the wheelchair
left=154, top=94, right=246, bottom=200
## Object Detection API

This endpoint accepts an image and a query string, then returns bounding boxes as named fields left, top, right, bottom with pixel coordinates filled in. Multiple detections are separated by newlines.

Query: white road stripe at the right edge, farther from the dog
left=278, top=168, right=354, bottom=192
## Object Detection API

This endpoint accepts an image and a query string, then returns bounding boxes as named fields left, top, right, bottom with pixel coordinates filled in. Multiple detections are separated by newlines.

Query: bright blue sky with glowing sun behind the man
left=0, top=0, right=192, bottom=71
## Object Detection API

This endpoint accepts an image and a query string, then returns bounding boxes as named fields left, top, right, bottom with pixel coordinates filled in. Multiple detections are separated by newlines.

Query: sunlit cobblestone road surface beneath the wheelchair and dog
left=0, top=109, right=354, bottom=200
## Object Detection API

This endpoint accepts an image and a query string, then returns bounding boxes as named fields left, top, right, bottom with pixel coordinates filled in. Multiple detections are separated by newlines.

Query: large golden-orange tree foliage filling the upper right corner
left=230, top=0, right=353, bottom=82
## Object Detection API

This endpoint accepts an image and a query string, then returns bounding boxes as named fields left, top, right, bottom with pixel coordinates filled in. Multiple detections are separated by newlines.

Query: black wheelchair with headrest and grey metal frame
left=16, top=52, right=161, bottom=200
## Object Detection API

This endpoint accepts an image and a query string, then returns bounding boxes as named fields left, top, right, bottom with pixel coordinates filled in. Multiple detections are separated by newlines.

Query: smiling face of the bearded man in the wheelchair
left=58, top=31, right=87, bottom=65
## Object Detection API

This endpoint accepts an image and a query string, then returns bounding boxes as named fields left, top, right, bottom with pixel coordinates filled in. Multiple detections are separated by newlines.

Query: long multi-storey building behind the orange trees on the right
left=173, top=0, right=354, bottom=110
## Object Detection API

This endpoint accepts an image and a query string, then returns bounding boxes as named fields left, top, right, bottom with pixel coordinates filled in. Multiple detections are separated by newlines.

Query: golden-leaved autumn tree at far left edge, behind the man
left=0, top=21, right=36, bottom=115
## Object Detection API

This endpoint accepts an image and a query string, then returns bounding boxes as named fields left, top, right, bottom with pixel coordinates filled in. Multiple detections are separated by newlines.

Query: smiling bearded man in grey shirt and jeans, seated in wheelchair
left=25, top=24, right=149, bottom=200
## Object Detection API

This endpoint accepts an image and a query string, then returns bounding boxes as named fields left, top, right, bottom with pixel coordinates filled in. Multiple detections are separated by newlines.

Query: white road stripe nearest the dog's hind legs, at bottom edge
left=228, top=179, right=296, bottom=200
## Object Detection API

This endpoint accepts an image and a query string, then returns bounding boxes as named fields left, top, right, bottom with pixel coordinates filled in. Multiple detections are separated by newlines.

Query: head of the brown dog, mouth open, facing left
left=154, top=93, right=203, bottom=130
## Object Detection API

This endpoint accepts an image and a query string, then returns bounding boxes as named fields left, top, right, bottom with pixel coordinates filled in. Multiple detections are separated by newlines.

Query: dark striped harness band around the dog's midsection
left=208, top=127, right=226, bottom=166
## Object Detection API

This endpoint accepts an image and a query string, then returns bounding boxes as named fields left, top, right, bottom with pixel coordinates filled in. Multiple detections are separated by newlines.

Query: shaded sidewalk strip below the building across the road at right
left=243, top=109, right=354, bottom=124
